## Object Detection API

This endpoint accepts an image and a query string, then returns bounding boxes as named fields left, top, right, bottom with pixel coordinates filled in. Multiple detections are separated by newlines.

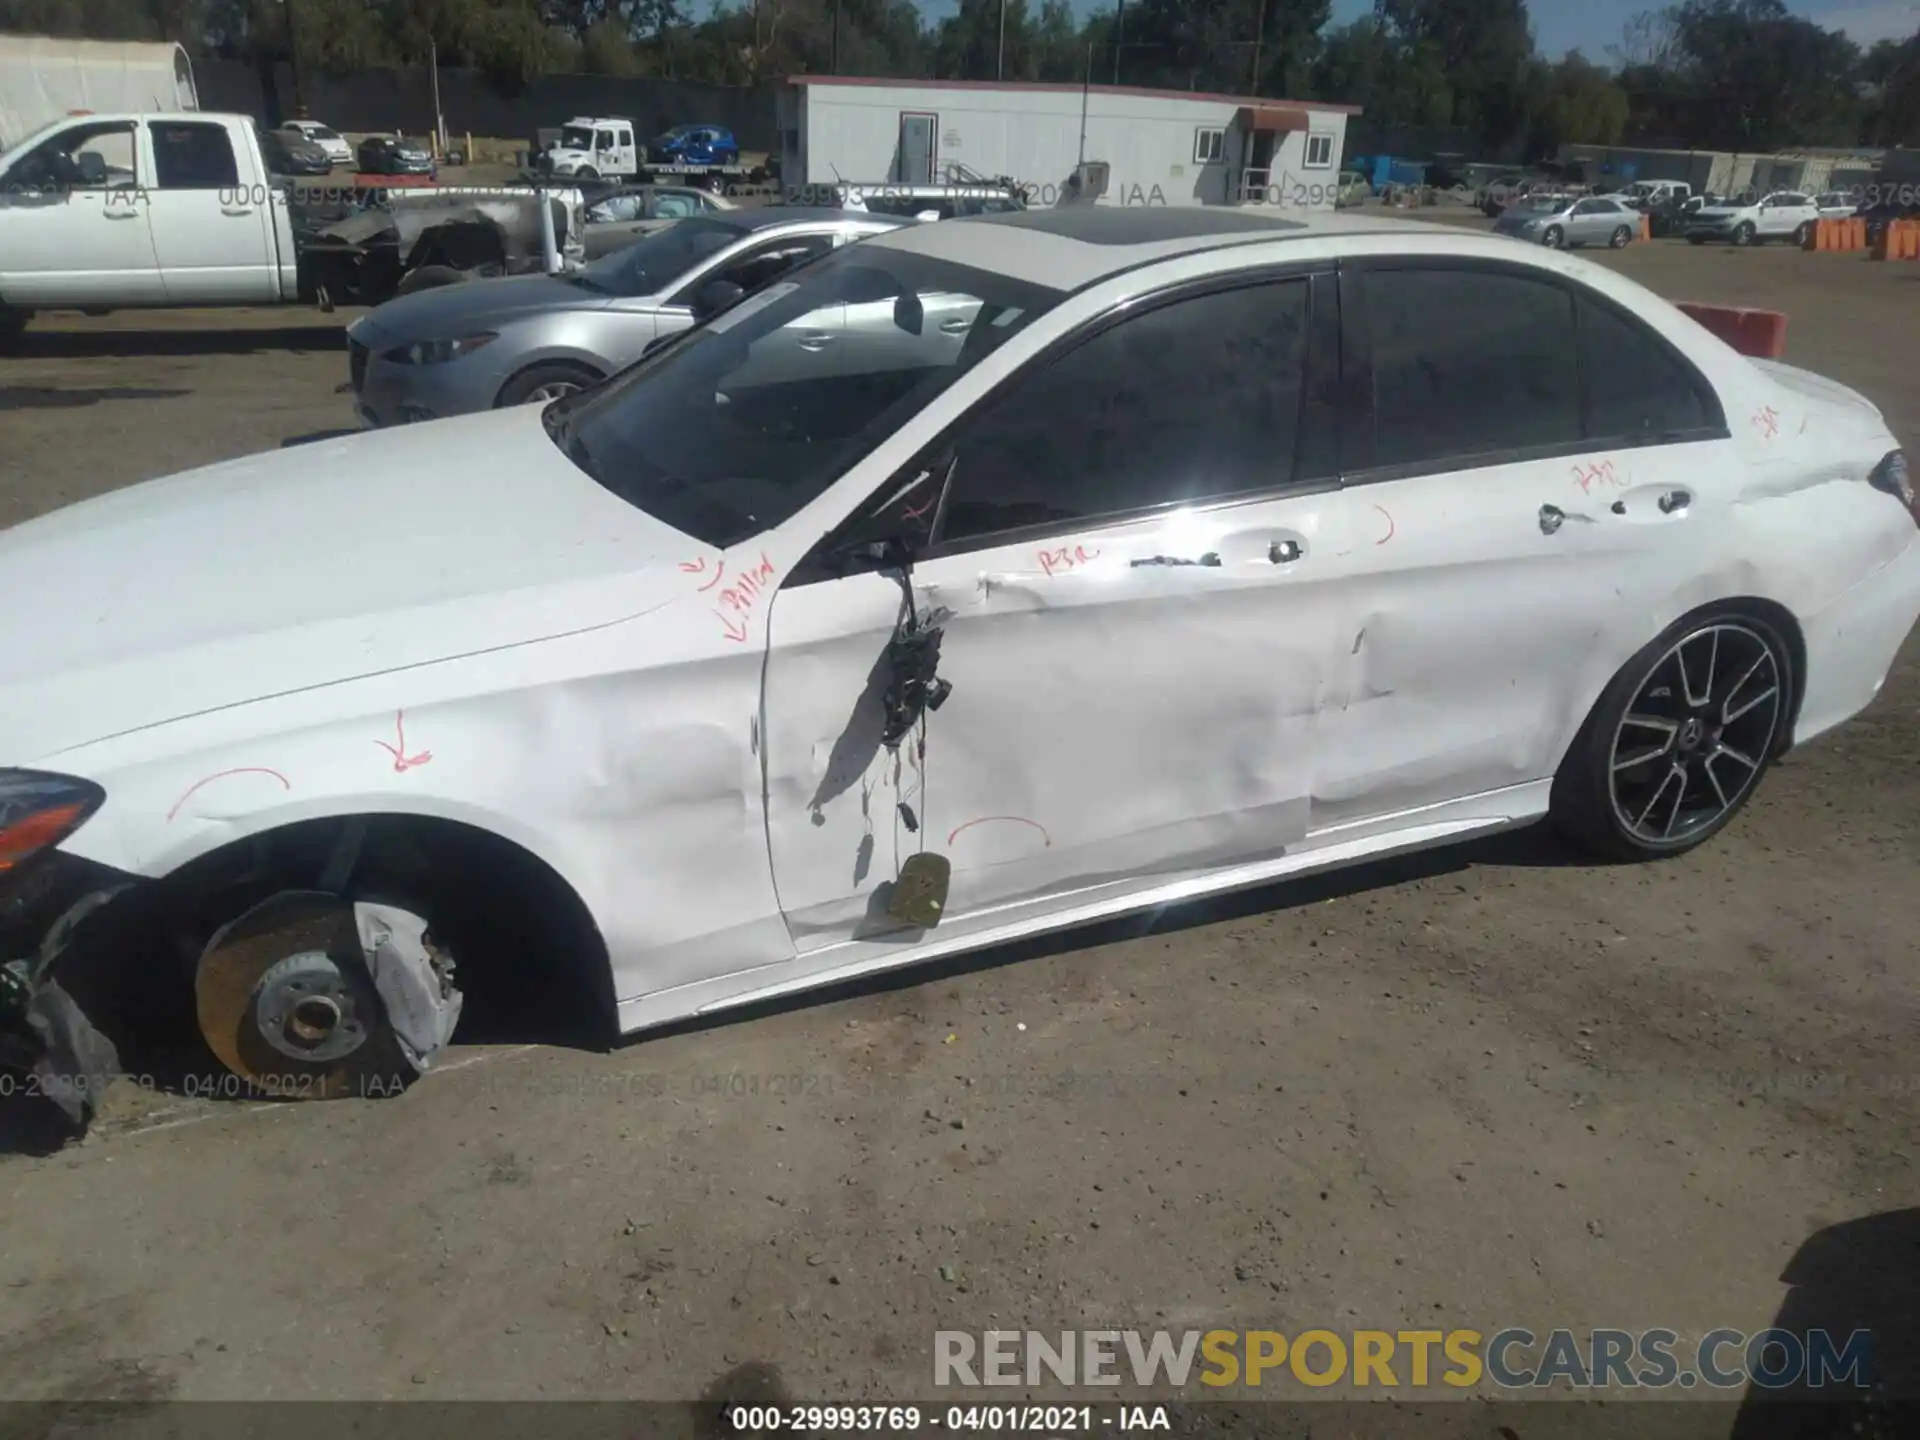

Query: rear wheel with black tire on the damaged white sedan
left=1549, top=607, right=1795, bottom=860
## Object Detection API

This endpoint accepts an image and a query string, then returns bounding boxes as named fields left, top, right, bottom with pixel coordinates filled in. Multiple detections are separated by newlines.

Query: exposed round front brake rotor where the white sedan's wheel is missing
left=194, top=891, right=407, bottom=1100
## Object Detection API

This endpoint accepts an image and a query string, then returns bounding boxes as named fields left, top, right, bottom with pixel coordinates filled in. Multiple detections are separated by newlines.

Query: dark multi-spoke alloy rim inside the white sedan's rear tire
left=1607, top=622, right=1786, bottom=849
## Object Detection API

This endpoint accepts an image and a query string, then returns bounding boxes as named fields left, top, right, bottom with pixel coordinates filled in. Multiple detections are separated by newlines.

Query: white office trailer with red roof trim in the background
left=780, top=75, right=1359, bottom=209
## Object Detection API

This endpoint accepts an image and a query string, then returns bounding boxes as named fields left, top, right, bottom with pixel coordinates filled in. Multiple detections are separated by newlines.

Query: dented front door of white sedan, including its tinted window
left=766, top=276, right=1350, bottom=964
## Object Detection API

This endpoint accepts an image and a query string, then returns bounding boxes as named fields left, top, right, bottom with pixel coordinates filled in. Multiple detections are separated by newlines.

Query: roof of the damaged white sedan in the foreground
left=864, top=205, right=1434, bottom=290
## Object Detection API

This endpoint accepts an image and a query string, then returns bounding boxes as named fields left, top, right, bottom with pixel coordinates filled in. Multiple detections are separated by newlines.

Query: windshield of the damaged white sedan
left=545, top=247, right=1062, bottom=547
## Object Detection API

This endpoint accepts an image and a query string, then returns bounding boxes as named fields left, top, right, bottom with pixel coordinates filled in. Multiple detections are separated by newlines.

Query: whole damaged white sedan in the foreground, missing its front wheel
left=0, top=207, right=1920, bottom=1117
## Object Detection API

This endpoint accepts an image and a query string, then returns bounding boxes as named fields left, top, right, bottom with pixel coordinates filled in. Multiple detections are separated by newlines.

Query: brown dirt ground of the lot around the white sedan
left=0, top=219, right=1920, bottom=1413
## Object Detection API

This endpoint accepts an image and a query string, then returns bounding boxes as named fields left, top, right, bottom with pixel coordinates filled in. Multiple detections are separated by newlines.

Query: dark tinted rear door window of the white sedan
left=1367, top=269, right=1580, bottom=465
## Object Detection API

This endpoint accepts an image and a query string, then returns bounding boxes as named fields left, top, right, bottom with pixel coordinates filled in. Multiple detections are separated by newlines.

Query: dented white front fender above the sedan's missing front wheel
left=39, top=586, right=791, bottom=1000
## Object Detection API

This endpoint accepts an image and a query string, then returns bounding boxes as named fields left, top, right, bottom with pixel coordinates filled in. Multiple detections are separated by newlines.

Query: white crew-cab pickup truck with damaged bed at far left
left=0, top=111, right=580, bottom=342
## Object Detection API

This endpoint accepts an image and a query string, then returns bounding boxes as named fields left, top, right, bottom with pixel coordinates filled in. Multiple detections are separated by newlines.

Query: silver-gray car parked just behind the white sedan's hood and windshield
left=348, top=205, right=910, bottom=428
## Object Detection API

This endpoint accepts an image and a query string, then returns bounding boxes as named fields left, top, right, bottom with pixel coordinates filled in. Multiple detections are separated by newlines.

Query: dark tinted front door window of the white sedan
left=941, top=280, right=1308, bottom=540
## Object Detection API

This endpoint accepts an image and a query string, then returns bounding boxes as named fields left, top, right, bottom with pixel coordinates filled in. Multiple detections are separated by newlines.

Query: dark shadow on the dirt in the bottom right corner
left=1722, top=1208, right=1920, bottom=1440
